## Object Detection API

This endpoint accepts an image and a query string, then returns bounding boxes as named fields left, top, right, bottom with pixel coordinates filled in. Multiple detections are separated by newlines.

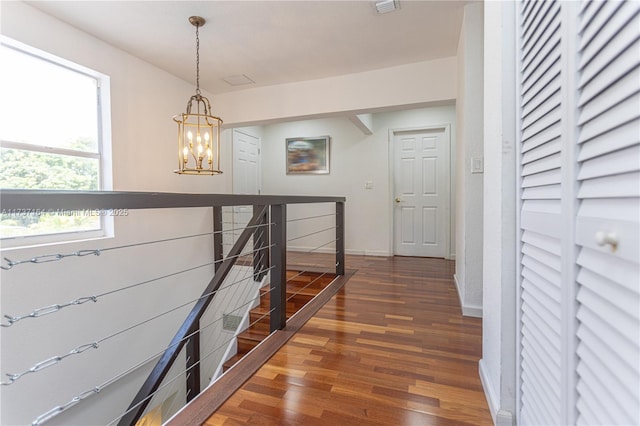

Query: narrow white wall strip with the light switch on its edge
left=455, top=3, right=483, bottom=316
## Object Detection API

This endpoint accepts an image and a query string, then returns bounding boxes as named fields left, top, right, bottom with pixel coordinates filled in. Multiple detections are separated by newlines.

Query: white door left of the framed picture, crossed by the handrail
left=231, top=129, right=260, bottom=247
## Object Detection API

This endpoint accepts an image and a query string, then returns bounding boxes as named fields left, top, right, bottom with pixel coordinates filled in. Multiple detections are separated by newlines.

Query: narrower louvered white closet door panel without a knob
left=520, top=1, right=562, bottom=425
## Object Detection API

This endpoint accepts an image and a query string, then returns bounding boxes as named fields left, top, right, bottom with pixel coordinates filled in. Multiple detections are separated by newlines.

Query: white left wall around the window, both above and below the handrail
left=0, top=2, right=231, bottom=425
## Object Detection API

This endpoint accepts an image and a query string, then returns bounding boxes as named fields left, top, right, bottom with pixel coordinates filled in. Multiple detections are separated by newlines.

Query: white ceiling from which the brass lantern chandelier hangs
left=27, top=0, right=469, bottom=94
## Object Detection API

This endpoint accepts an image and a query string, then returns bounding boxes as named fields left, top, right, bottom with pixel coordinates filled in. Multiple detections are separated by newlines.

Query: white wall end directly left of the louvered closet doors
left=480, top=2, right=517, bottom=426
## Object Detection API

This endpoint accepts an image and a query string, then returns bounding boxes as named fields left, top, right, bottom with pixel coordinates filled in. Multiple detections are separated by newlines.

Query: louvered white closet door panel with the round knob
left=576, top=1, right=640, bottom=425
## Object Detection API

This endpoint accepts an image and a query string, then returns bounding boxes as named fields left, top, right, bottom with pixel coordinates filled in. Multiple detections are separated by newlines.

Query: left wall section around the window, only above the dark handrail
left=2, top=2, right=231, bottom=193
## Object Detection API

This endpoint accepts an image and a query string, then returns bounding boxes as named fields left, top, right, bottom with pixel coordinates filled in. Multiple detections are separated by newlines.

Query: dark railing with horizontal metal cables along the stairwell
left=0, top=190, right=345, bottom=425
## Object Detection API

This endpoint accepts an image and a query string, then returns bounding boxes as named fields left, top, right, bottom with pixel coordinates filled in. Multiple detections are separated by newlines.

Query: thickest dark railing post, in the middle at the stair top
left=269, top=204, right=287, bottom=333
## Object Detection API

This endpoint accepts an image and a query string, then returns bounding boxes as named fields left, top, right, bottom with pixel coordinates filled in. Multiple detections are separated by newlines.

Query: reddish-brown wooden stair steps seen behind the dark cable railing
left=222, top=271, right=336, bottom=371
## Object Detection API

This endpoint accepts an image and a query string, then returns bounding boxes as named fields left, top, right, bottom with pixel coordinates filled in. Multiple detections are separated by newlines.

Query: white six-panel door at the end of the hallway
left=393, top=127, right=450, bottom=257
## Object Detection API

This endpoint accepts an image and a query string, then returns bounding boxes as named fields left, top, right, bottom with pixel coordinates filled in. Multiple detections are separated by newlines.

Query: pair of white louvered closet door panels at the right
left=518, top=0, right=640, bottom=425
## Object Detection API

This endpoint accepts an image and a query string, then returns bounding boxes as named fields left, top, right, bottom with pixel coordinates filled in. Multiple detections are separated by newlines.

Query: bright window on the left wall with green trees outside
left=0, top=37, right=111, bottom=246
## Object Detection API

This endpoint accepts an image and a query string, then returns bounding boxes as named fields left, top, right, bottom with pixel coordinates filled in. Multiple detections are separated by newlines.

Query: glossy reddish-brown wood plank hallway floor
left=205, top=256, right=492, bottom=426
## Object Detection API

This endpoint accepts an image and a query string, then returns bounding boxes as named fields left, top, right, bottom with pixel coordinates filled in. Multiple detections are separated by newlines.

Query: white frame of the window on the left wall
left=0, top=35, right=114, bottom=250
